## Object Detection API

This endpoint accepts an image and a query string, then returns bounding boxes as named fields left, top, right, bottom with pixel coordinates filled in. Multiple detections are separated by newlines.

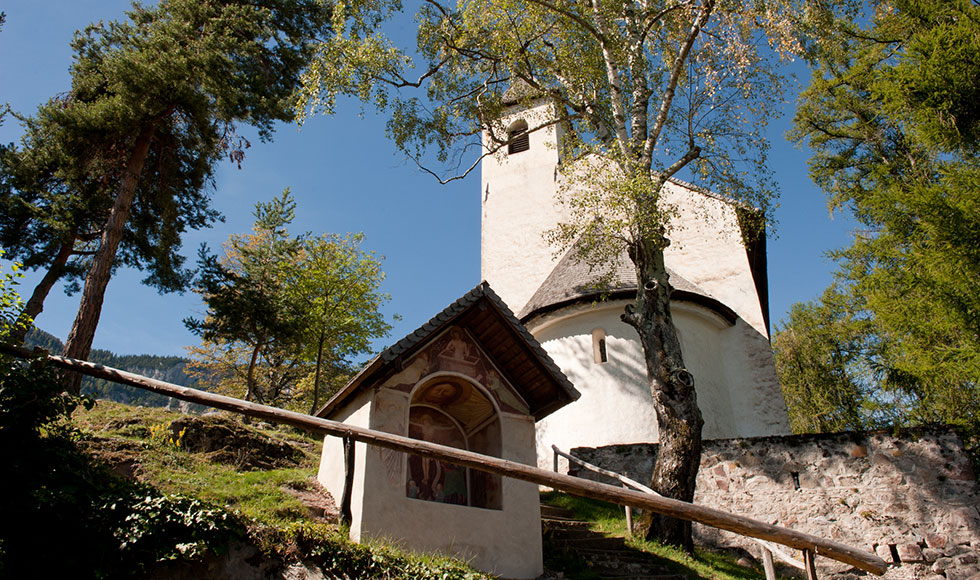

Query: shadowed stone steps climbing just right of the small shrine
left=541, top=504, right=687, bottom=580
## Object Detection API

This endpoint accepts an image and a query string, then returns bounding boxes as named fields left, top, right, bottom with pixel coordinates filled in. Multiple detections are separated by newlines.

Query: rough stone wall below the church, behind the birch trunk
left=572, top=428, right=980, bottom=580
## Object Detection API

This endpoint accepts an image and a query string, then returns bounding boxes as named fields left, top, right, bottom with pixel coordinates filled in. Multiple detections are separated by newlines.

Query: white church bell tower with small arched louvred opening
left=480, top=85, right=562, bottom=313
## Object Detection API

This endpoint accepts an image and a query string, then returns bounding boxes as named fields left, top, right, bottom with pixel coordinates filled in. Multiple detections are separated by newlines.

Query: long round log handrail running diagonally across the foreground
left=0, top=343, right=886, bottom=580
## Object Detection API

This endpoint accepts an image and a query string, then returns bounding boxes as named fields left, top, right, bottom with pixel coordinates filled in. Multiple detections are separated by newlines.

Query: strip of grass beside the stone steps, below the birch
left=541, top=492, right=765, bottom=580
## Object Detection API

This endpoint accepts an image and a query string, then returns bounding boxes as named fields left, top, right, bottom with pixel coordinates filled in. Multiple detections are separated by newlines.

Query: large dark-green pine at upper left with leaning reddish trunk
left=0, top=0, right=329, bottom=388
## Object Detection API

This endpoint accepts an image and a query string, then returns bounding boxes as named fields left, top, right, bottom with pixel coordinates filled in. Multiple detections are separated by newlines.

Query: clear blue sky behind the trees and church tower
left=0, top=0, right=853, bottom=354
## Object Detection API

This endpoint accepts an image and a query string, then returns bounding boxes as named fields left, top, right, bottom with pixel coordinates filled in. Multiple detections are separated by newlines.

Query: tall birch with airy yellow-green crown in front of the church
left=303, top=0, right=819, bottom=547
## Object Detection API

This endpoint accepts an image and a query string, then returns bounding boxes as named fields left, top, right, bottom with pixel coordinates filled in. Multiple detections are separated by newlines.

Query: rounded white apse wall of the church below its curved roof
left=530, top=301, right=789, bottom=468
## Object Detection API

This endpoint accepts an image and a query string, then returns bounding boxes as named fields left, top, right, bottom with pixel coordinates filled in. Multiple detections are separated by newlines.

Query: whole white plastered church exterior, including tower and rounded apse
left=481, top=101, right=789, bottom=467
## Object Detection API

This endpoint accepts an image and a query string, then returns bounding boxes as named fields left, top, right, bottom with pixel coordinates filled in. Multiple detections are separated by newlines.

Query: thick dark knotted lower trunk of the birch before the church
left=622, top=236, right=704, bottom=552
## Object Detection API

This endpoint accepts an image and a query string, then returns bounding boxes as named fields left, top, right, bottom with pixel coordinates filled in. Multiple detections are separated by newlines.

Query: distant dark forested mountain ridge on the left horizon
left=25, top=328, right=203, bottom=410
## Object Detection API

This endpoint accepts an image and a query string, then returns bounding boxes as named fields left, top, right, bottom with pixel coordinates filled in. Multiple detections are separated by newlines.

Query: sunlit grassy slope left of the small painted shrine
left=72, top=401, right=484, bottom=580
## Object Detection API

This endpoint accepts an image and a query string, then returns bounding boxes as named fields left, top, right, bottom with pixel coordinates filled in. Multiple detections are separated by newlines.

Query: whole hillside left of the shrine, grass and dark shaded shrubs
left=0, top=359, right=483, bottom=580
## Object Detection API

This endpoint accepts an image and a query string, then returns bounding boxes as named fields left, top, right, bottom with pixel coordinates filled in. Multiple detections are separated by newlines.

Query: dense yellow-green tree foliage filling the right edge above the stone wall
left=776, top=0, right=980, bottom=440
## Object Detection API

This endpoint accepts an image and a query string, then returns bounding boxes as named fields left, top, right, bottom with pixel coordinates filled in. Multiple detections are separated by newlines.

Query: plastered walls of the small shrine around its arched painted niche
left=320, top=329, right=543, bottom=578
